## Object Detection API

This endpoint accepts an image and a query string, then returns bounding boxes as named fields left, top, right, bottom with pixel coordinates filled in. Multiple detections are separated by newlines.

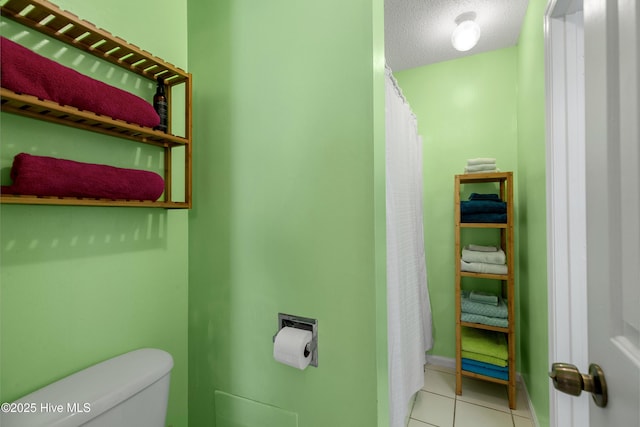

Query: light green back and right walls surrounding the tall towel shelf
left=396, top=0, right=549, bottom=426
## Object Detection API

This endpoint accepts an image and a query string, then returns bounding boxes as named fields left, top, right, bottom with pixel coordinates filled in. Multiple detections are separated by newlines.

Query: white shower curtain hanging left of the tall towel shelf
left=385, top=68, right=433, bottom=427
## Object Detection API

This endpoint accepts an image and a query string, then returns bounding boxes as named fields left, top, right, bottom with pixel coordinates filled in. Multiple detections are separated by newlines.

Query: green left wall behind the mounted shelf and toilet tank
left=0, top=0, right=188, bottom=427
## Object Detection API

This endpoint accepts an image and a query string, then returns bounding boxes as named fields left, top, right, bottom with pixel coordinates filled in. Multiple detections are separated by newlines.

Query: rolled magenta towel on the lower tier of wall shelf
left=2, top=153, right=164, bottom=200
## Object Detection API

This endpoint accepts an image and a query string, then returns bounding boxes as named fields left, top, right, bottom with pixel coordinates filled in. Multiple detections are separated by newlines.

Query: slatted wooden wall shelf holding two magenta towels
left=0, top=0, right=192, bottom=209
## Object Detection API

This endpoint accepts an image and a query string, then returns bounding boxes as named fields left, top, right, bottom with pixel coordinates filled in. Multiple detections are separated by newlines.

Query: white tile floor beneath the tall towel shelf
left=408, top=365, right=534, bottom=427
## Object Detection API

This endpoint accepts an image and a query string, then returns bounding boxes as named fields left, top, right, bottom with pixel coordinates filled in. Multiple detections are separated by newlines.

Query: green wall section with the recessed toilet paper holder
left=189, top=0, right=386, bottom=427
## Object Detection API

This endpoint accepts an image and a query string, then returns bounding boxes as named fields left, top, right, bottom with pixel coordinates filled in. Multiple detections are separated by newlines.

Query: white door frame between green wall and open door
left=545, top=0, right=589, bottom=427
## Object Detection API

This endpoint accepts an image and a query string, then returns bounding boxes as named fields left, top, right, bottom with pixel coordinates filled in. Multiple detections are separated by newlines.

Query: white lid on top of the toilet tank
left=1, top=348, right=173, bottom=427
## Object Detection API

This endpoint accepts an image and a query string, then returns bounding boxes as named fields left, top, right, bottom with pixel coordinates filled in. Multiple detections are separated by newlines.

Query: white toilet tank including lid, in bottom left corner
left=0, top=348, right=173, bottom=427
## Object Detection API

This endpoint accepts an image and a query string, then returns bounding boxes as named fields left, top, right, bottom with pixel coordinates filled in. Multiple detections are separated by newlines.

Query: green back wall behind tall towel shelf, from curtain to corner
left=395, top=47, right=517, bottom=358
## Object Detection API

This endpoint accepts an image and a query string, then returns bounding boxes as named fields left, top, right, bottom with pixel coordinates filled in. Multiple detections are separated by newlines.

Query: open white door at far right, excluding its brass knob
left=584, top=0, right=640, bottom=427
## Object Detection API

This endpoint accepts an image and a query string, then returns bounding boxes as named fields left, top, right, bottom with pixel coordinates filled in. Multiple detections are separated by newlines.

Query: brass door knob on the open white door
left=549, top=363, right=607, bottom=408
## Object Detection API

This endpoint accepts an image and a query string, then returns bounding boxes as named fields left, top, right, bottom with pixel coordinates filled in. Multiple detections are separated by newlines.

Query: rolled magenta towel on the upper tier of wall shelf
left=0, top=37, right=160, bottom=128
